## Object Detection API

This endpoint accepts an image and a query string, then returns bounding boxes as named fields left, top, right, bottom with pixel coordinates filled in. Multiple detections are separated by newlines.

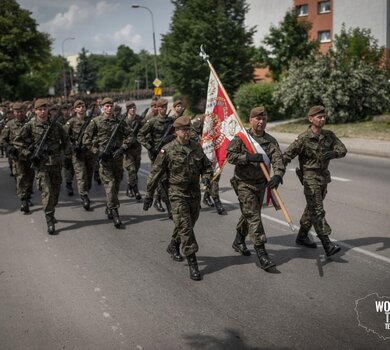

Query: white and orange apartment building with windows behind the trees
left=246, top=0, right=390, bottom=52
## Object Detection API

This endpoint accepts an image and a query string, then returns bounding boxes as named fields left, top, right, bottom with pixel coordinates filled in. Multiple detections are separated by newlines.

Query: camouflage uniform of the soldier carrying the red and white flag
left=227, top=130, right=285, bottom=245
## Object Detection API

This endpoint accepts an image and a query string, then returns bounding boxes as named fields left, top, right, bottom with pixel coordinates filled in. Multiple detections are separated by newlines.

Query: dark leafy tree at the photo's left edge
left=0, top=0, right=51, bottom=99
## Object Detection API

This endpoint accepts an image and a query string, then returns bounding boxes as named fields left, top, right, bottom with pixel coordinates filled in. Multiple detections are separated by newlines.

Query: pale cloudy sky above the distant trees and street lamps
left=16, top=0, right=174, bottom=56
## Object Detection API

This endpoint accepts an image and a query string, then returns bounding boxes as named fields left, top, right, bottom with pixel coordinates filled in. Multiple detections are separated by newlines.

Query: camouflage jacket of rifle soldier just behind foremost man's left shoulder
left=137, top=116, right=174, bottom=152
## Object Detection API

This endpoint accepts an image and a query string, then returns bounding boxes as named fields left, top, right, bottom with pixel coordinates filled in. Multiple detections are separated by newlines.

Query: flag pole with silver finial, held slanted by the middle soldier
left=199, top=45, right=295, bottom=232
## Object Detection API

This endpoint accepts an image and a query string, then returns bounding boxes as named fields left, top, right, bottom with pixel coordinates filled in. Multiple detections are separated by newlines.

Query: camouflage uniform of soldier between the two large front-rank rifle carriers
left=64, top=116, right=96, bottom=197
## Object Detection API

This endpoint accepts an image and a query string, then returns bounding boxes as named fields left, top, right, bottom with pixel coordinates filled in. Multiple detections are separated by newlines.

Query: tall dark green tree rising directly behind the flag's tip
left=161, top=0, right=254, bottom=110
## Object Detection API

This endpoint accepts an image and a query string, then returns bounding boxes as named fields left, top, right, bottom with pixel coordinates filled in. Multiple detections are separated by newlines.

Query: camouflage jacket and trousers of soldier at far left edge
left=0, top=118, right=34, bottom=201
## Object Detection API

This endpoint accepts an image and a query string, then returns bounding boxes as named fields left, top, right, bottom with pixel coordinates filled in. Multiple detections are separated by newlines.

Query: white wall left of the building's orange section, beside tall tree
left=245, top=0, right=290, bottom=47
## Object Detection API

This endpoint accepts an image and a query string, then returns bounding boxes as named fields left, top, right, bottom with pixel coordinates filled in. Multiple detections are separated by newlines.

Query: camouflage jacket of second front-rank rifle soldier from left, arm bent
left=83, top=115, right=131, bottom=154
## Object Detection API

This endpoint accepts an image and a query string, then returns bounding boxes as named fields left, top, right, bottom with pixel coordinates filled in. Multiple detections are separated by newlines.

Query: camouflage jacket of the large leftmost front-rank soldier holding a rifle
left=14, top=118, right=70, bottom=165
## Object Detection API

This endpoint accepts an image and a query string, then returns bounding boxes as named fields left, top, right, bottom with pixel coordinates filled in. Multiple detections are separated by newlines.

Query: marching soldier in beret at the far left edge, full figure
left=0, top=102, right=34, bottom=214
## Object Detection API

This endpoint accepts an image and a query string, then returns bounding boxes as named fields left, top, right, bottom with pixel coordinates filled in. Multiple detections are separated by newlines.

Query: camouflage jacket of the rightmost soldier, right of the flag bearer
left=283, top=127, right=347, bottom=182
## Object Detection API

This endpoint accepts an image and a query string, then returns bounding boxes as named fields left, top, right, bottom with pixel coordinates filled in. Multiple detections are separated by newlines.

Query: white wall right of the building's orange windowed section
left=333, top=0, right=390, bottom=48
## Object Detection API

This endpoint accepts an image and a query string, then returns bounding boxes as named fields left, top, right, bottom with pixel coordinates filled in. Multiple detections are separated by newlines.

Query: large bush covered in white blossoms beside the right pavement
left=275, top=26, right=390, bottom=123
